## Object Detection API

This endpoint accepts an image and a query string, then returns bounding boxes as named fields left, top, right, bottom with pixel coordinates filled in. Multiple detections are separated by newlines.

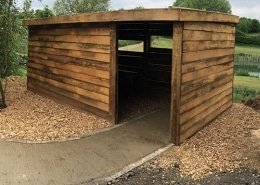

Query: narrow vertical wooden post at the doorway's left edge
left=109, top=23, right=117, bottom=124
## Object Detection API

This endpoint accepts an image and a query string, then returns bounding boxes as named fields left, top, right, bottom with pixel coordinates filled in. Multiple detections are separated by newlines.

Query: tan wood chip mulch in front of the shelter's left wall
left=0, top=77, right=111, bottom=143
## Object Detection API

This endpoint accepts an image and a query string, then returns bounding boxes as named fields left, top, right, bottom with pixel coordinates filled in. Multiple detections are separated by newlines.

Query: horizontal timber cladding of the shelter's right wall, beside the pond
left=179, top=22, right=235, bottom=142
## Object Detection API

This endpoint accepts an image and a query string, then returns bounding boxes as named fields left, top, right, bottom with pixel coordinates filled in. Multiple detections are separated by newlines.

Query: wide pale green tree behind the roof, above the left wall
left=53, top=0, right=110, bottom=15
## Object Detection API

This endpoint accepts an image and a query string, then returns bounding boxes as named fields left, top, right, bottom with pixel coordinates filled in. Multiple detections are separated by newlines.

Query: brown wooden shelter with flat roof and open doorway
left=24, top=8, right=239, bottom=144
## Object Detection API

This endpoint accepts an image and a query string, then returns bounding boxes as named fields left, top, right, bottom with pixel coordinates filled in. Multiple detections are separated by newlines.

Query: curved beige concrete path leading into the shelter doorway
left=0, top=108, right=169, bottom=185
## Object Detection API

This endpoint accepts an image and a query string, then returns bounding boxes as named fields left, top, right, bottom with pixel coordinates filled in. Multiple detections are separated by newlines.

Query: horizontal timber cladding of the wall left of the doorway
left=27, top=23, right=113, bottom=120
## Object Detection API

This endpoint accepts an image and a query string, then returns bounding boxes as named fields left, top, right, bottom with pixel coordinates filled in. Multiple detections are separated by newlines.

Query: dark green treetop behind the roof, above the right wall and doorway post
left=173, top=0, right=232, bottom=14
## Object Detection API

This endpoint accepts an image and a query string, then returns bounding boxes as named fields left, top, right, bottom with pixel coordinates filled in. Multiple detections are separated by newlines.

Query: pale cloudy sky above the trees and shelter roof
left=18, top=0, right=260, bottom=20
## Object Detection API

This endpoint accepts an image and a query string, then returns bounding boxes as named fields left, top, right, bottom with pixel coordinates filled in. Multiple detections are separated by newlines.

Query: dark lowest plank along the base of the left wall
left=27, top=76, right=109, bottom=112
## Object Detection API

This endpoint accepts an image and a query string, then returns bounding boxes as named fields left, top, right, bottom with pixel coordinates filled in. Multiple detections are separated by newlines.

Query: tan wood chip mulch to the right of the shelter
left=155, top=103, right=260, bottom=179
